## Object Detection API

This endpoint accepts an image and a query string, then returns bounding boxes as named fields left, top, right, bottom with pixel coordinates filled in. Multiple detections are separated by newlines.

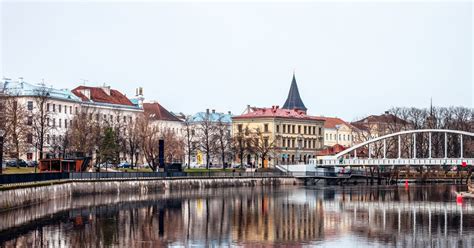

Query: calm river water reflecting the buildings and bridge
left=0, top=185, right=474, bottom=248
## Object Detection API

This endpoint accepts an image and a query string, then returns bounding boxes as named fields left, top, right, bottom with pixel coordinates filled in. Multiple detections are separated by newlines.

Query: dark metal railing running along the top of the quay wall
left=0, top=172, right=290, bottom=185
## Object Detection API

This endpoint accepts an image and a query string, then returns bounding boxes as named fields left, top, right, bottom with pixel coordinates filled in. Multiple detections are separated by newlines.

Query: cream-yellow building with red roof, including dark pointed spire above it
left=232, top=75, right=324, bottom=167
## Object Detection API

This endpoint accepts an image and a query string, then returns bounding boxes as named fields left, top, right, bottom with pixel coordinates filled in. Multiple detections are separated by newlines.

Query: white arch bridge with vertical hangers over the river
left=309, top=129, right=474, bottom=167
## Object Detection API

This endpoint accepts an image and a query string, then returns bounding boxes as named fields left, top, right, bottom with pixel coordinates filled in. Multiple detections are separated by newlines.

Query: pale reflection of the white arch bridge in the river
left=322, top=201, right=474, bottom=247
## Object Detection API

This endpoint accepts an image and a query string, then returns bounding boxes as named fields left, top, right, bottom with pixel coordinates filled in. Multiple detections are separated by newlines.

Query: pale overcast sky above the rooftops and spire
left=1, top=1, right=474, bottom=121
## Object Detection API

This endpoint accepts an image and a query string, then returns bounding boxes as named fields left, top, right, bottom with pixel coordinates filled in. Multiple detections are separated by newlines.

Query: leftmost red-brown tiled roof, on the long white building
left=71, top=86, right=135, bottom=106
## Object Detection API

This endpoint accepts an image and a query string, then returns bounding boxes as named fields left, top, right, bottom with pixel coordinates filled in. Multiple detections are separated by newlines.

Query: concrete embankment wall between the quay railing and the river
left=0, top=177, right=300, bottom=210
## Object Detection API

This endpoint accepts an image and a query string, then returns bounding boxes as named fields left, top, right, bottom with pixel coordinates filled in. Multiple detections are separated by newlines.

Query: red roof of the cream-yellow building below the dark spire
left=232, top=106, right=323, bottom=121
